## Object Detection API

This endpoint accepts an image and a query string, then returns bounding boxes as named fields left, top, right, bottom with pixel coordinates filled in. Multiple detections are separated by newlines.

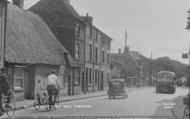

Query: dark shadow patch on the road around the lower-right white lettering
left=152, top=96, right=185, bottom=119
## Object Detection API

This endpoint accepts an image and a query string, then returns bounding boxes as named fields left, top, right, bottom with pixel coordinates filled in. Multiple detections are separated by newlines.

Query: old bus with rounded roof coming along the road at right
left=156, top=71, right=176, bottom=94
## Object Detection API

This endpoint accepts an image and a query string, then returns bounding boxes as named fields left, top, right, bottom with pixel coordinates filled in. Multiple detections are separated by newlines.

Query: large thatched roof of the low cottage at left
left=5, top=4, right=73, bottom=65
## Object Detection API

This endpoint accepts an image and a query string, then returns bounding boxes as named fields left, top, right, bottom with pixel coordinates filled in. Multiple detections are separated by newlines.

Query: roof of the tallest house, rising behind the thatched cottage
left=29, top=0, right=86, bottom=24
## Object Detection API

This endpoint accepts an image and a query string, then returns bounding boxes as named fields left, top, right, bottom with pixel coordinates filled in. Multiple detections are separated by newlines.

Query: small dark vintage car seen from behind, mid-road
left=108, top=79, right=129, bottom=99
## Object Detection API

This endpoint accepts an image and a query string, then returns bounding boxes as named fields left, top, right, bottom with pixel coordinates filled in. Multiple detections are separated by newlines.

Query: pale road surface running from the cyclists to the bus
left=1, top=87, right=189, bottom=117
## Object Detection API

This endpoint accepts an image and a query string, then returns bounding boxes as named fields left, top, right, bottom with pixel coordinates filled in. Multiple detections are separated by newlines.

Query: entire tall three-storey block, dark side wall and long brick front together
left=29, top=0, right=111, bottom=95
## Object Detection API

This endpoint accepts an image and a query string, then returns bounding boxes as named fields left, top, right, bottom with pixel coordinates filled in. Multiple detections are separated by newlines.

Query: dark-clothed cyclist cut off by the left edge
left=0, top=67, right=11, bottom=113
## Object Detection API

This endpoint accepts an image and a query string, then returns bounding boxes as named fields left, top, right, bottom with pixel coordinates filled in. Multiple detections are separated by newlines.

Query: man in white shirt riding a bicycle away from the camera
left=47, top=70, right=60, bottom=108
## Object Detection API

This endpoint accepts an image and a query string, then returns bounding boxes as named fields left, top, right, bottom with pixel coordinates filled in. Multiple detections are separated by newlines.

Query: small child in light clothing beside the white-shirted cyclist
left=36, top=80, right=44, bottom=105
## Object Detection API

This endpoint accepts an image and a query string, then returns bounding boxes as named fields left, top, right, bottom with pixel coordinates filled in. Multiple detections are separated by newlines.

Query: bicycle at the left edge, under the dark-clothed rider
left=2, top=92, right=16, bottom=118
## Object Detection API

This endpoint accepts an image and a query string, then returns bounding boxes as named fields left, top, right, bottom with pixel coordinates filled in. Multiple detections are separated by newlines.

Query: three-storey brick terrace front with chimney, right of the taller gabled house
left=82, top=13, right=112, bottom=91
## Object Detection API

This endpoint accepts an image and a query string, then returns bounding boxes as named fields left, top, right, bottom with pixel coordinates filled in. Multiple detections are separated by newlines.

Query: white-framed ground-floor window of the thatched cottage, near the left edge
left=14, top=68, right=24, bottom=89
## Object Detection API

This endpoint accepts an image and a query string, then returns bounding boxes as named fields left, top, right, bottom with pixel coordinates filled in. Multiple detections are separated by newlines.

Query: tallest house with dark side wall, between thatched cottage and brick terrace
left=29, top=0, right=86, bottom=95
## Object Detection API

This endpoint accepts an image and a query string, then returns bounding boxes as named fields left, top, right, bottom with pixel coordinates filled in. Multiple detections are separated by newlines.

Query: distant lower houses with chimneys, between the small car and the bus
left=110, top=46, right=153, bottom=87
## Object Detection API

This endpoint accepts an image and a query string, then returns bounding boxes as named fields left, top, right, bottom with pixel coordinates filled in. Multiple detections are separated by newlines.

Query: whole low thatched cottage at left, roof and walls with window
left=0, top=0, right=74, bottom=100
